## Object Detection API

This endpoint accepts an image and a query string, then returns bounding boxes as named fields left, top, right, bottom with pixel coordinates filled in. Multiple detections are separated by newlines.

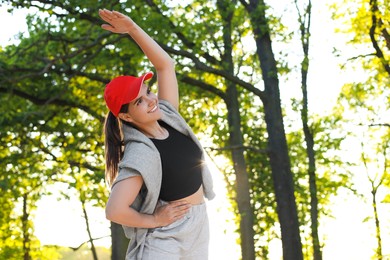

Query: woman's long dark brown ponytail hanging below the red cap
left=104, top=104, right=129, bottom=186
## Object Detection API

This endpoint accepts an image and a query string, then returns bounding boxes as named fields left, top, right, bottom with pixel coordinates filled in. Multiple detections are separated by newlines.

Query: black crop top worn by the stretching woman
left=151, top=121, right=202, bottom=201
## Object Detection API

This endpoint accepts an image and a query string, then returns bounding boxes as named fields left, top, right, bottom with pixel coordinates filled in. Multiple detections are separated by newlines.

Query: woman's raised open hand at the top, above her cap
left=99, top=9, right=135, bottom=33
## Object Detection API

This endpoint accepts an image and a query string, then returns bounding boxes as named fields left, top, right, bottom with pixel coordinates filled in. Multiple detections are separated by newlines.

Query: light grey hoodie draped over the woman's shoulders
left=113, top=100, right=215, bottom=259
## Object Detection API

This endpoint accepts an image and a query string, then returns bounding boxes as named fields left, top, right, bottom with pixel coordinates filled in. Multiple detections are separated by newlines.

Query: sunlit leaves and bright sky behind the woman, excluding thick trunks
left=0, top=1, right=390, bottom=259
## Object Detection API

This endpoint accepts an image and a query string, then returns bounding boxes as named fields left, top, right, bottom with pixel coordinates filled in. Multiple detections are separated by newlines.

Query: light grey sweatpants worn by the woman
left=142, top=203, right=209, bottom=260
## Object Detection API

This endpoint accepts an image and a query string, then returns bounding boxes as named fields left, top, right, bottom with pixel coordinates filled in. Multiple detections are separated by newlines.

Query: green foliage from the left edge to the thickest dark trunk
left=0, top=0, right=310, bottom=256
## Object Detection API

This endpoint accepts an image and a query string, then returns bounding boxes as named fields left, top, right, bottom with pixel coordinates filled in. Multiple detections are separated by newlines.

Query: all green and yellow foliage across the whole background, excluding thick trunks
left=0, top=0, right=390, bottom=259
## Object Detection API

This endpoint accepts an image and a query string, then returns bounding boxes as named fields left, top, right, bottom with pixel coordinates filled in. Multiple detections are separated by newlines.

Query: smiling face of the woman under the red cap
left=120, top=83, right=162, bottom=127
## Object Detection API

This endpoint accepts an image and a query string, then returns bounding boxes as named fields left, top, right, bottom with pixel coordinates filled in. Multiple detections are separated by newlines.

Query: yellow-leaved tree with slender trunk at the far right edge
left=334, top=0, right=390, bottom=259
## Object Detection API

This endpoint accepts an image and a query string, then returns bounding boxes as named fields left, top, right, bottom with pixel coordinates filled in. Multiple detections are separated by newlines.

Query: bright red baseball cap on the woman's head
left=104, top=72, right=153, bottom=116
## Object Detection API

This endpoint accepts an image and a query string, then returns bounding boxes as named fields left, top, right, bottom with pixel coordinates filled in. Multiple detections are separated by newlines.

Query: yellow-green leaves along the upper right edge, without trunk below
left=336, top=1, right=390, bottom=197
